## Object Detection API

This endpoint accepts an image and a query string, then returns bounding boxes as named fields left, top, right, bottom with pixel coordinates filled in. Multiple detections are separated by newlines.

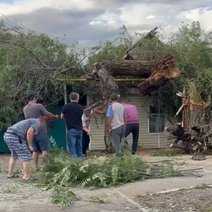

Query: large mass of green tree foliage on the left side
left=0, top=23, right=82, bottom=128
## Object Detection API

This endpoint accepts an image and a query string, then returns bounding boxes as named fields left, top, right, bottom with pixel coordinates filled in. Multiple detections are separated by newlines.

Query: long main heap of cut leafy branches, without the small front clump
left=43, top=152, right=177, bottom=188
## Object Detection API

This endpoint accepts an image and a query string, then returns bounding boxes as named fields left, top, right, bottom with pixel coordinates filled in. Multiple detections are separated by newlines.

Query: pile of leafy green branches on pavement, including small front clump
left=41, top=149, right=179, bottom=207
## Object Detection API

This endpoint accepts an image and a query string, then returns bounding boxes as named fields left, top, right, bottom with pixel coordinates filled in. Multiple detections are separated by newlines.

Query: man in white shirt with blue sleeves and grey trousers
left=107, top=94, right=125, bottom=156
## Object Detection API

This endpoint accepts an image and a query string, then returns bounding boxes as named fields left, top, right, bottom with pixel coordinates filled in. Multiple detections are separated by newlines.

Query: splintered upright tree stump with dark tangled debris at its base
left=167, top=83, right=212, bottom=160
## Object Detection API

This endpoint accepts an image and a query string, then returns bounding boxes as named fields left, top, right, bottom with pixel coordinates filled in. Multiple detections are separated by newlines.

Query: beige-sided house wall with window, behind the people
left=90, top=93, right=168, bottom=150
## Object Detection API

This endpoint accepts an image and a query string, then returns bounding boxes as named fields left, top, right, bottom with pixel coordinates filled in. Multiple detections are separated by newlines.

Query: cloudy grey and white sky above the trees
left=0, top=0, right=212, bottom=46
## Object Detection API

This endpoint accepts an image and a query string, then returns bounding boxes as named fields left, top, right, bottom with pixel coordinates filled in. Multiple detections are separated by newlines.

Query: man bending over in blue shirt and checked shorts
left=4, top=116, right=47, bottom=180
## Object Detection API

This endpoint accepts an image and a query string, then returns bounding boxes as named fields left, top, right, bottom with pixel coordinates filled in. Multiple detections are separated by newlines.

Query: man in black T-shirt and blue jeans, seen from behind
left=61, top=92, right=84, bottom=158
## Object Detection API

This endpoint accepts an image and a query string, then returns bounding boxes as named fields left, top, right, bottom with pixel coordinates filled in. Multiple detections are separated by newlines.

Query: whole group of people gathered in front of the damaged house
left=4, top=91, right=139, bottom=181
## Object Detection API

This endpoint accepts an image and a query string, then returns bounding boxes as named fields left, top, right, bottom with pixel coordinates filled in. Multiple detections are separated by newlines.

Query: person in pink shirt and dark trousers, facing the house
left=123, top=103, right=139, bottom=155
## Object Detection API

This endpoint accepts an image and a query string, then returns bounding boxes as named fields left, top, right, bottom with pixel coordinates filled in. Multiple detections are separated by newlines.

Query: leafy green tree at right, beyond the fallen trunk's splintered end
left=169, top=22, right=212, bottom=101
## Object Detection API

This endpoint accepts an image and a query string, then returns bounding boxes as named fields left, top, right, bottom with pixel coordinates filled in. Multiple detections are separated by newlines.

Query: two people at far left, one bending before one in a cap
left=4, top=91, right=59, bottom=181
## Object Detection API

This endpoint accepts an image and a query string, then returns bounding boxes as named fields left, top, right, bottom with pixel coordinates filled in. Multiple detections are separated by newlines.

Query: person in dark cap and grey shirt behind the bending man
left=23, top=91, right=59, bottom=170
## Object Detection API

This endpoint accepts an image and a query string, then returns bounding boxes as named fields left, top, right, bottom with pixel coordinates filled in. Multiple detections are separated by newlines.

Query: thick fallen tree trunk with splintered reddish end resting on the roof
left=88, top=56, right=180, bottom=95
